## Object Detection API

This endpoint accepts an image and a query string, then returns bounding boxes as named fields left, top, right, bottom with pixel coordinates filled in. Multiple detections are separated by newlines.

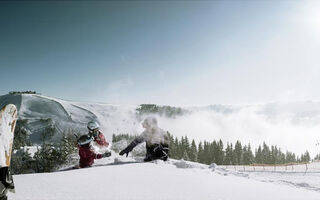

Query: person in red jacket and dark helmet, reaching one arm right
left=78, top=135, right=111, bottom=168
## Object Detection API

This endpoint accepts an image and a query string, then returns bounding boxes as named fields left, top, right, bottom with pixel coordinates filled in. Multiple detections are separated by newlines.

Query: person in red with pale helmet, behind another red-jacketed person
left=87, top=121, right=109, bottom=149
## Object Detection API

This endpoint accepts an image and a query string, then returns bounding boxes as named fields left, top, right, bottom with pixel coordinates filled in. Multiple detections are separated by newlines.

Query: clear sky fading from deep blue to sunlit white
left=0, top=0, right=320, bottom=105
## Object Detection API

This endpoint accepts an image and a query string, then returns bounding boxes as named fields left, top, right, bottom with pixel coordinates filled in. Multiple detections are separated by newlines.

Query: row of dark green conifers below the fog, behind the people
left=112, top=133, right=311, bottom=165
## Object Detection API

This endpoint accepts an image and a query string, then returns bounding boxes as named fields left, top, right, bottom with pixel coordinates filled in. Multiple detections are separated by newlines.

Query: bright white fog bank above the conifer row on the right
left=159, top=103, right=320, bottom=156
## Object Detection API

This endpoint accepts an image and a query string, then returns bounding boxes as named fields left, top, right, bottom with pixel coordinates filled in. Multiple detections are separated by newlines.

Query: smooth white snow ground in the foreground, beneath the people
left=9, top=154, right=320, bottom=200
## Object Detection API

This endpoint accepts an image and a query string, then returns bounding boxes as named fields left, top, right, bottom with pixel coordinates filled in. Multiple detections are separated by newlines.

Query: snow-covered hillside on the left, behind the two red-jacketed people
left=0, top=94, right=141, bottom=143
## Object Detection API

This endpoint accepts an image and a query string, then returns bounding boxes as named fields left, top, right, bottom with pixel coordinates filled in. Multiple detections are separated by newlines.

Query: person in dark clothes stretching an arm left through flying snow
left=119, top=117, right=169, bottom=162
